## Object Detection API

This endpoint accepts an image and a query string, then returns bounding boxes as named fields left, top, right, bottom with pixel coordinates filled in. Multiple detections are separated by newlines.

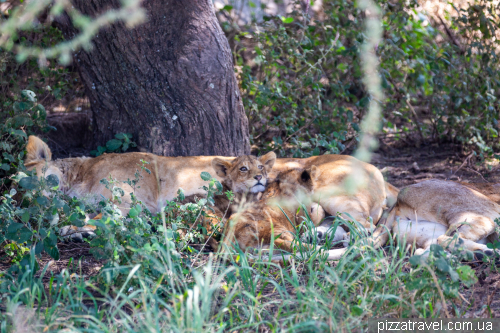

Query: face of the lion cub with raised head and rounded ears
left=212, top=152, right=276, bottom=193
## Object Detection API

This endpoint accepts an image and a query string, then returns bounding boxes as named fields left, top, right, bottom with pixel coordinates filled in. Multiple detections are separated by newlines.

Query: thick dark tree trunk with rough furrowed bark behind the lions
left=59, top=0, right=250, bottom=156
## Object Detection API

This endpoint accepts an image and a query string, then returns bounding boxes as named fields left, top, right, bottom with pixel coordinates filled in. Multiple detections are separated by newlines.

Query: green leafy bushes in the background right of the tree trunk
left=223, top=0, right=500, bottom=156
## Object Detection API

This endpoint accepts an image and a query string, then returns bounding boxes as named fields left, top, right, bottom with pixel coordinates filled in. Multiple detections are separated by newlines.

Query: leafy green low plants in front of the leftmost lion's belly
left=90, top=169, right=222, bottom=269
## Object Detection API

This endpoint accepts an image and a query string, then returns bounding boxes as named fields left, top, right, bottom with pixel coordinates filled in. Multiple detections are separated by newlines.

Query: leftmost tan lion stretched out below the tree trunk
left=25, top=136, right=236, bottom=213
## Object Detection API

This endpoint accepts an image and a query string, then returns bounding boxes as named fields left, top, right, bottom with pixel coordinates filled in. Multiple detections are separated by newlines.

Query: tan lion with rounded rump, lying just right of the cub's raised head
left=266, top=155, right=399, bottom=250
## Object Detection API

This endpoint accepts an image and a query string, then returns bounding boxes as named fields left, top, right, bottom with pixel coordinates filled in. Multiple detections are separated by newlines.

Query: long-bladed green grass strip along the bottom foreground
left=0, top=202, right=488, bottom=332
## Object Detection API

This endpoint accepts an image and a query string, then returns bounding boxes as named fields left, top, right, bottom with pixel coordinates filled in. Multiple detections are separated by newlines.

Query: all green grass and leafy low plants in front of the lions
left=0, top=164, right=495, bottom=332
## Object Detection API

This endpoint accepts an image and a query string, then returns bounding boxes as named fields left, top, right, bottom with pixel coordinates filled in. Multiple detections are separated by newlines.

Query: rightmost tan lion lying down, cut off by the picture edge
left=373, top=180, right=500, bottom=254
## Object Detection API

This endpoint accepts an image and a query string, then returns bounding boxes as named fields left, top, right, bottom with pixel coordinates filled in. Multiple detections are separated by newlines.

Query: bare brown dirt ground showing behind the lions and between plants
left=0, top=137, right=500, bottom=318
